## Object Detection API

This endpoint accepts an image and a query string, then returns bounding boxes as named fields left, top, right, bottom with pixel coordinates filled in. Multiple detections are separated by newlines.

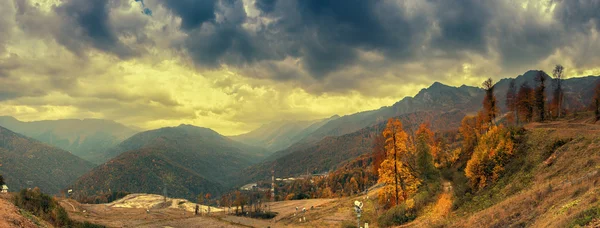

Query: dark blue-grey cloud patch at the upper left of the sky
left=55, top=0, right=135, bottom=58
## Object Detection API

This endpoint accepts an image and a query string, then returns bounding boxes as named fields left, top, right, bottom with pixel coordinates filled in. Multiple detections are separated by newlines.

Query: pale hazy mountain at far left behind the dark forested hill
left=0, top=116, right=136, bottom=164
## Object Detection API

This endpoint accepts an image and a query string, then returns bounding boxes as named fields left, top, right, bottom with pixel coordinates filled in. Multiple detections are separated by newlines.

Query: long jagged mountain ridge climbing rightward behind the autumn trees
left=240, top=70, right=600, bottom=183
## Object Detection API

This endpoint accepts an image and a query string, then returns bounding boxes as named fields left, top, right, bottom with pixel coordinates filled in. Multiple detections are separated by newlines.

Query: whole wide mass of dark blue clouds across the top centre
left=163, top=0, right=427, bottom=79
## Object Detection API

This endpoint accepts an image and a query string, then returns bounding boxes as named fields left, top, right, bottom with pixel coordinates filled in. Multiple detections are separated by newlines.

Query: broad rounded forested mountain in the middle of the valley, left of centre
left=72, top=125, right=267, bottom=200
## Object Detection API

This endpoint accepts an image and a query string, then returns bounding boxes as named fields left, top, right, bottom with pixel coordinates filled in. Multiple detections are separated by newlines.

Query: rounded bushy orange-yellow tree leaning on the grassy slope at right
left=465, top=125, right=514, bottom=190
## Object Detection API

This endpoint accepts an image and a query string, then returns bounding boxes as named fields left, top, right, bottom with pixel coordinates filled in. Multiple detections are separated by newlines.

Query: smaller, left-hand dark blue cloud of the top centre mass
left=163, top=0, right=270, bottom=68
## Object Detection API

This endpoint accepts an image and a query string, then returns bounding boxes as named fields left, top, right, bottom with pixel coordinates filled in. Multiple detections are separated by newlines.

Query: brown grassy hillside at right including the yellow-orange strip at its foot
left=366, top=114, right=600, bottom=227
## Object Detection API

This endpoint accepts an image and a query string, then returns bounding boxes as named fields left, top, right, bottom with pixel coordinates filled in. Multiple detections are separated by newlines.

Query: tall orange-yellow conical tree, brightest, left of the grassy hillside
left=378, top=118, right=421, bottom=205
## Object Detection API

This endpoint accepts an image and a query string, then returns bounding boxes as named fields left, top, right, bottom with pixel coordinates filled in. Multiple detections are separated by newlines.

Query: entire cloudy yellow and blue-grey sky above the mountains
left=0, top=0, right=600, bottom=135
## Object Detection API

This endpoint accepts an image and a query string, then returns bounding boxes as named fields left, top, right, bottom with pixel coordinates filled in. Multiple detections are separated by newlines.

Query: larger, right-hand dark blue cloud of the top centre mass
left=257, top=0, right=427, bottom=79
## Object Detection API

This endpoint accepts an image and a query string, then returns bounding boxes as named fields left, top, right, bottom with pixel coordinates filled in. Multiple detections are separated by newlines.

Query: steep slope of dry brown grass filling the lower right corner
left=450, top=118, right=600, bottom=227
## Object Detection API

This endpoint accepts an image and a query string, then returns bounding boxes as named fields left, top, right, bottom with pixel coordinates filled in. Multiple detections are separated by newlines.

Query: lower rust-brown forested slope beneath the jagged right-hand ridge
left=238, top=110, right=467, bottom=184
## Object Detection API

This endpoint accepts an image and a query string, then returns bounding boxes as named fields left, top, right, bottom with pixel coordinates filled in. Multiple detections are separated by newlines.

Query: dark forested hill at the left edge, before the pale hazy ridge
left=0, top=127, right=94, bottom=194
